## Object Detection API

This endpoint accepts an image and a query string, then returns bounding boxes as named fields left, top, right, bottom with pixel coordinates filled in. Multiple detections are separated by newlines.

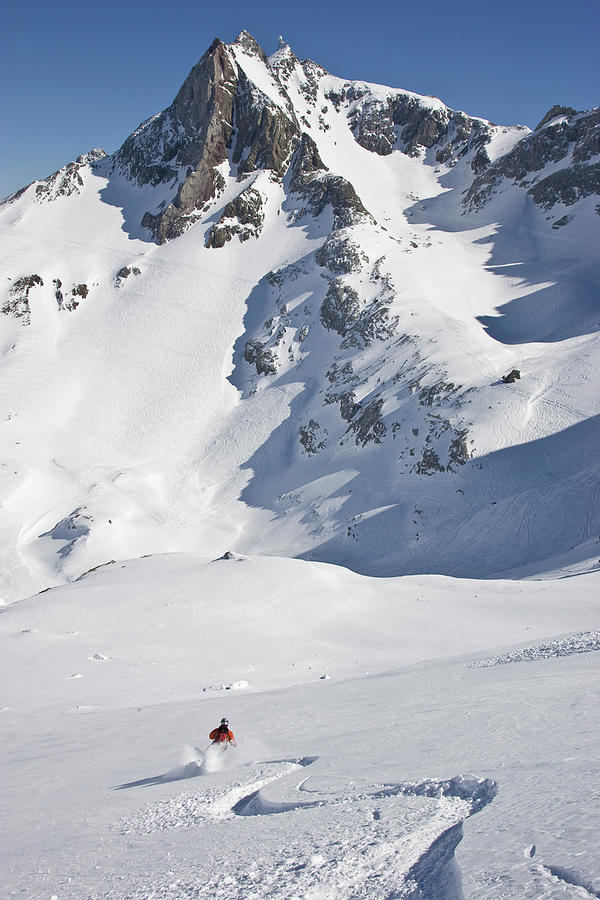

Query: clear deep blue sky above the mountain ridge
left=0, top=0, right=600, bottom=196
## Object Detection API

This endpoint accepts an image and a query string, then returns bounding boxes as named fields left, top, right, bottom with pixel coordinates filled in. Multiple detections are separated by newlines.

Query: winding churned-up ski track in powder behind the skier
left=101, top=757, right=497, bottom=900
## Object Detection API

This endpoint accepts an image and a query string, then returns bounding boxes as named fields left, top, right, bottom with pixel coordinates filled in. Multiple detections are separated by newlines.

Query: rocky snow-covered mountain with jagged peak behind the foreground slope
left=0, top=32, right=600, bottom=601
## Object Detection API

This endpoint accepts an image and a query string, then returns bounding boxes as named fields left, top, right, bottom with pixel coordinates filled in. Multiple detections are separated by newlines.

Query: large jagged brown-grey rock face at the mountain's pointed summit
left=115, top=31, right=300, bottom=246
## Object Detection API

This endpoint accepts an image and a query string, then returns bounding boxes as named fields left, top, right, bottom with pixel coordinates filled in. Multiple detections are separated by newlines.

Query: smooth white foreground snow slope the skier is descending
left=0, top=554, right=600, bottom=900
